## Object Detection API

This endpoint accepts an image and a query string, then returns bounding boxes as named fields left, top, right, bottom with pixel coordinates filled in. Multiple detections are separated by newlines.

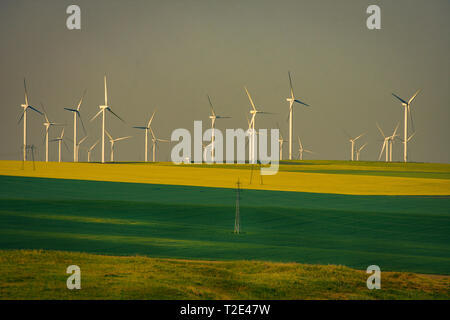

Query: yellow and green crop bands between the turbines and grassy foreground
left=0, top=161, right=450, bottom=298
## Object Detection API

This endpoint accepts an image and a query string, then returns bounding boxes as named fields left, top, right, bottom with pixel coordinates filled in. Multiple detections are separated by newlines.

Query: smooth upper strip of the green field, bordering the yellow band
left=0, top=176, right=450, bottom=215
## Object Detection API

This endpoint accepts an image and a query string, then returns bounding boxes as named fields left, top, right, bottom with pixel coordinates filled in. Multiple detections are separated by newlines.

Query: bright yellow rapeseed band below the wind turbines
left=0, top=161, right=450, bottom=195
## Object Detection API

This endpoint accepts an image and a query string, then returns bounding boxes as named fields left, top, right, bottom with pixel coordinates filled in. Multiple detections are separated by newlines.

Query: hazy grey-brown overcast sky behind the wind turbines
left=0, top=0, right=450, bottom=163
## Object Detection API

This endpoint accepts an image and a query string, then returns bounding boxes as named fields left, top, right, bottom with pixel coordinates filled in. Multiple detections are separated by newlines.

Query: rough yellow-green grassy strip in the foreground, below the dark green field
left=0, top=250, right=450, bottom=300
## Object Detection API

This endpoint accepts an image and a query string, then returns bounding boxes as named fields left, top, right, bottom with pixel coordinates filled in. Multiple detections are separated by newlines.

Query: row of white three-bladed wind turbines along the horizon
left=15, top=72, right=420, bottom=163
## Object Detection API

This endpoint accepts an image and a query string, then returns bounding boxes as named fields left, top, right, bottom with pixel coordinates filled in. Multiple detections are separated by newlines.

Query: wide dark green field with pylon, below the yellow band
left=0, top=176, right=450, bottom=274
